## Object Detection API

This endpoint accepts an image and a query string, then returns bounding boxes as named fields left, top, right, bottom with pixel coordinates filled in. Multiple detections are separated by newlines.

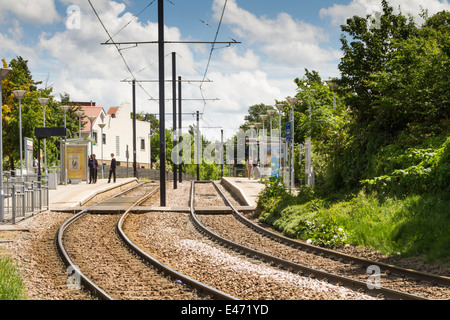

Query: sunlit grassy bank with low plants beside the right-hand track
left=260, top=188, right=450, bottom=263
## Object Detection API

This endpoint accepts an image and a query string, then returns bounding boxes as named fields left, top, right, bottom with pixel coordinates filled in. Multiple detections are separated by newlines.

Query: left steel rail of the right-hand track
left=190, top=181, right=427, bottom=300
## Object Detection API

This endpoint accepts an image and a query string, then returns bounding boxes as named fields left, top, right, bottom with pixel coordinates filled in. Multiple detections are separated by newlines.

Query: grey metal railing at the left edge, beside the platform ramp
left=0, top=172, right=50, bottom=224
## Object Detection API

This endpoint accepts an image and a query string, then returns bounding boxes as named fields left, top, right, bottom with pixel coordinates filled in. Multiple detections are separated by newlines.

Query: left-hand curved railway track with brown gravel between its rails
left=57, top=184, right=234, bottom=300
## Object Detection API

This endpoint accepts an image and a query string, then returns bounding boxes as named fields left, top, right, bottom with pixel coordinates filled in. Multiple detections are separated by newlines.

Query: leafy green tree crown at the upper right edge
left=370, top=12, right=450, bottom=141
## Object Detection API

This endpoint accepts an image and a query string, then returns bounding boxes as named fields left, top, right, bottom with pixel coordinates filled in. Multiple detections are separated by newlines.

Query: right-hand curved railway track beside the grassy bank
left=191, top=182, right=450, bottom=300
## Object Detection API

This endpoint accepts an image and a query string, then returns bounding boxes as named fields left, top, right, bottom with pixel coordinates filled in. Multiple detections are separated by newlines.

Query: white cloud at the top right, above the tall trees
left=320, top=0, right=450, bottom=25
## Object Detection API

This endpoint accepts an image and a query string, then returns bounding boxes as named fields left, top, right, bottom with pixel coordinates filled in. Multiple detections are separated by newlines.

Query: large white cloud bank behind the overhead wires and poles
left=0, top=0, right=338, bottom=141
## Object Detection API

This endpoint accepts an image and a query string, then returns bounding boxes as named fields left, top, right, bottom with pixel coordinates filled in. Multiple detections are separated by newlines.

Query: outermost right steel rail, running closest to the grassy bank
left=219, top=181, right=450, bottom=286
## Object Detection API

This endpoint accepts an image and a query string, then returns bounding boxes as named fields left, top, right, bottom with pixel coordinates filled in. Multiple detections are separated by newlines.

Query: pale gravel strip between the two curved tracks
left=119, top=183, right=373, bottom=301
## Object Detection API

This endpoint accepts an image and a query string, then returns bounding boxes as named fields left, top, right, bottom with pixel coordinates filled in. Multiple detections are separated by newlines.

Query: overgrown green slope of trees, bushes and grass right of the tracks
left=258, top=1, right=450, bottom=262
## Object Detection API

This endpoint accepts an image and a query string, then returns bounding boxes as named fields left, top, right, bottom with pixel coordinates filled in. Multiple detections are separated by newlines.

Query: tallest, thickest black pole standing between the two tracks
left=158, top=0, right=166, bottom=207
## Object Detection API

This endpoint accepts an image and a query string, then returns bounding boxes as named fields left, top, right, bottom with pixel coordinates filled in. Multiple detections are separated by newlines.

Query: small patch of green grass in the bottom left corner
left=0, top=255, right=26, bottom=300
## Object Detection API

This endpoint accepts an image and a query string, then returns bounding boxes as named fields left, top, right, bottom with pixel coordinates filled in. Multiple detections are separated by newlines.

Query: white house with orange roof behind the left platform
left=74, top=102, right=151, bottom=168
